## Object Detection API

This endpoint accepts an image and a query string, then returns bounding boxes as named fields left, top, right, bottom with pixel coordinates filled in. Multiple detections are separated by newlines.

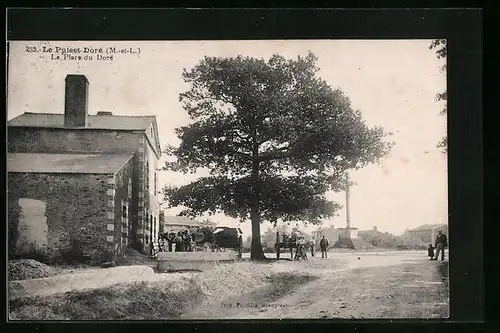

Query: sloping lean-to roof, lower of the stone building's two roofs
left=7, top=153, right=133, bottom=174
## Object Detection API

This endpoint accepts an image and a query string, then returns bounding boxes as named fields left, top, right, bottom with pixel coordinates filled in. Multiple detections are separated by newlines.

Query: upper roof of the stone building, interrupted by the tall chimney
left=7, top=112, right=156, bottom=130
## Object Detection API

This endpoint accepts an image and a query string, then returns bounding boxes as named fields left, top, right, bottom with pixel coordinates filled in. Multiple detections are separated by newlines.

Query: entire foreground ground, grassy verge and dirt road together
left=9, top=251, right=448, bottom=320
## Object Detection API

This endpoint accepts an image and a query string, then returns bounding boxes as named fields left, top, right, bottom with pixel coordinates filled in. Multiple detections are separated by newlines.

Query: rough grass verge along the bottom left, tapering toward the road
left=9, top=263, right=278, bottom=320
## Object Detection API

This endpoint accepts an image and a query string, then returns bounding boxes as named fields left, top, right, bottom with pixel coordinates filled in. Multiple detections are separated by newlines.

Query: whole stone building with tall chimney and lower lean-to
left=7, top=75, right=161, bottom=261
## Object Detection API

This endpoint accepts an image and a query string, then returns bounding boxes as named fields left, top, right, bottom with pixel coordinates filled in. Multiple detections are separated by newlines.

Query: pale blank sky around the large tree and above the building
left=7, top=40, right=448, bottom=235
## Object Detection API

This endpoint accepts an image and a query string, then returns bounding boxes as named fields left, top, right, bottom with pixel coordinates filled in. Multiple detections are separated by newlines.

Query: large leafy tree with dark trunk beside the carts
left=164, top=53, right=390, bottom=259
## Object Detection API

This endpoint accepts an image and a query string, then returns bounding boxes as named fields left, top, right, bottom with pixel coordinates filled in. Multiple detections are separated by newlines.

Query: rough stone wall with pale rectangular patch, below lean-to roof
left=7, top=173, right=108, bottom=263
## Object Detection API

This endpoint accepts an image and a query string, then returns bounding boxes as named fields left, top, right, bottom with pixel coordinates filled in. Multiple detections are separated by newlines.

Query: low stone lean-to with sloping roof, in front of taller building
left=8, top=153, right=133, bottom=263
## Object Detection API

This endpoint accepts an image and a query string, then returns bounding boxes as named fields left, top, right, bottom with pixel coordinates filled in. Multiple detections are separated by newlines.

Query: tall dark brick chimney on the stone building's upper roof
left=64, top=74, right=89, bottom=127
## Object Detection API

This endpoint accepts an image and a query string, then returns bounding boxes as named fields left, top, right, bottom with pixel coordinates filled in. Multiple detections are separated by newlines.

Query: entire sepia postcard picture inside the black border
left=6, top=39, right=453, bottom=321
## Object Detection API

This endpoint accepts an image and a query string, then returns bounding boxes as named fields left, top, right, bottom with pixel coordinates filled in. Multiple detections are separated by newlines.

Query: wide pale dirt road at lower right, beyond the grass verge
left=184, top=251, right=448, bottom=319
